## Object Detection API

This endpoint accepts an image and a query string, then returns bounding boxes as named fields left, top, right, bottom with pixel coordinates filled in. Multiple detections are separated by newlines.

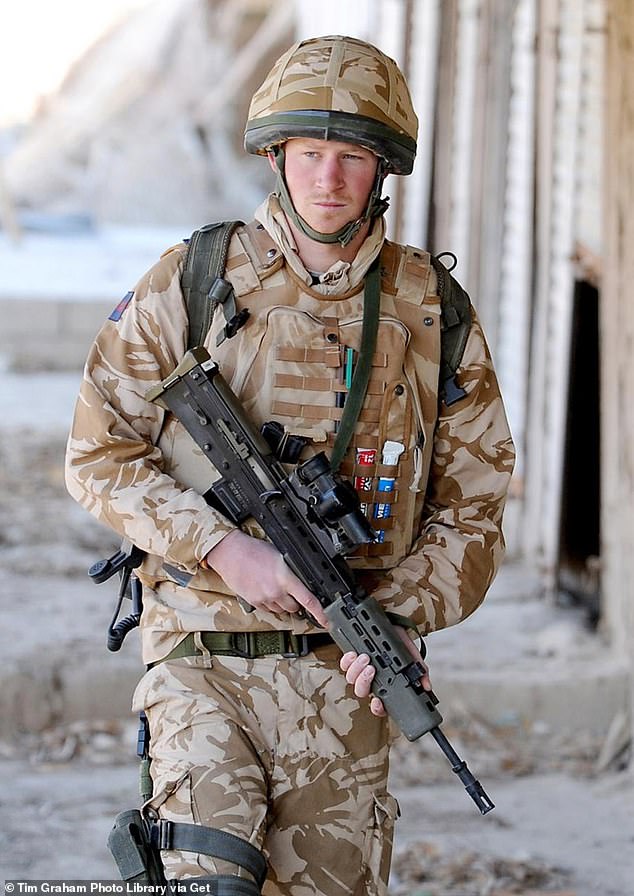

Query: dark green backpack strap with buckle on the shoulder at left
left=181, top=221, right=249, bottom=349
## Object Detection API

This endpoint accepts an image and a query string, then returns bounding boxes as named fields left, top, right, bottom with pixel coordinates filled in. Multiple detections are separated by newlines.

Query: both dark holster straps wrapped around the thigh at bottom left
left=151, top=818, right=267, bottom=896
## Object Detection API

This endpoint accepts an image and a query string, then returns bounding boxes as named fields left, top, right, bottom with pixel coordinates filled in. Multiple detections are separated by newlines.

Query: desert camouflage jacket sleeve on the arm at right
left=372, top=318, right=515, bottom=634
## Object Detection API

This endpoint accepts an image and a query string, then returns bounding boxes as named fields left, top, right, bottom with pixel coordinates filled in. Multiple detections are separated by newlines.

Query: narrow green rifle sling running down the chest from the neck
left=330, top=255, right=381, bottom=471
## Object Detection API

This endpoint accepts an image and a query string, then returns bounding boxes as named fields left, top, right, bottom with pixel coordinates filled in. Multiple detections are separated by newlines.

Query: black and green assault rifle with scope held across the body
left=146, top=347, right=494, bottom=815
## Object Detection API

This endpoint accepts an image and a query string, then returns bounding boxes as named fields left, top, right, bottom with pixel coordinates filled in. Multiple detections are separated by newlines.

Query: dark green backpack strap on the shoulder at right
left=431, top=253, right=473, bottom=405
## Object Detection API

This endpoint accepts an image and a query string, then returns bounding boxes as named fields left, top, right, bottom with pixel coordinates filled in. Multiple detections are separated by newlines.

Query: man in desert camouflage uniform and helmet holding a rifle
left=67, top=37, right=513, bottom=896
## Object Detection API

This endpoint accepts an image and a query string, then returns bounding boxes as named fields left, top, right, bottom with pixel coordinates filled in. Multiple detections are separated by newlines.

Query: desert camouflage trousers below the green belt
left=134, top=645, right=398, bottom=896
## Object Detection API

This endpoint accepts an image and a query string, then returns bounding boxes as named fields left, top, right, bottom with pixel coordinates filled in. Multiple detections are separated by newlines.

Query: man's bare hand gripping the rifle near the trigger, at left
left=205, top=529, right=328, bottom=628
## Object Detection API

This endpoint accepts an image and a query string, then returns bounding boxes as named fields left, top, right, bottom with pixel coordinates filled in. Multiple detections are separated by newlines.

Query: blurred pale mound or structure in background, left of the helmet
left=5, top=0, right=294, bottom=228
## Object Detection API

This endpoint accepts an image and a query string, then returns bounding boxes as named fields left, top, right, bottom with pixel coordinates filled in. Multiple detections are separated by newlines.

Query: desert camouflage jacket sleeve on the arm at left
left=66, top=246, right=234, bottom=573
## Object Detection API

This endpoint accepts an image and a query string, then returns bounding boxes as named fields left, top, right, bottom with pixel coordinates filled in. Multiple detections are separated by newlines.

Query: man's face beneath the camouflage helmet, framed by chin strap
left=276, top=137, right=378, bottom=233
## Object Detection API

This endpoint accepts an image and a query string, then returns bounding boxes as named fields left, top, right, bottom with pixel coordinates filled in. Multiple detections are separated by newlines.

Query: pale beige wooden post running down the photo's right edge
left=599, top=0, right=634, bottom=660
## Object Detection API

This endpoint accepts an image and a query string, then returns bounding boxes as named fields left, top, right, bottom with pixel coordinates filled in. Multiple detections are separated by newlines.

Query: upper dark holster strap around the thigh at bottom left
left=151, top=818, right=267, bottom=887
